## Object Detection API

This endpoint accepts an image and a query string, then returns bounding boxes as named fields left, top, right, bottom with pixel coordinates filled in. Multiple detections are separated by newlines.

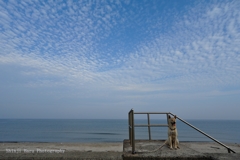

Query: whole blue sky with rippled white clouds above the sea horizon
left=0, top=0, right=240, bottom=119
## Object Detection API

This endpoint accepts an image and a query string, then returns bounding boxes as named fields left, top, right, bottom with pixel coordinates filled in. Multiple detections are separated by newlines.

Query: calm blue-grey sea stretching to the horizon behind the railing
left=0, top=119, right=240, bottom=143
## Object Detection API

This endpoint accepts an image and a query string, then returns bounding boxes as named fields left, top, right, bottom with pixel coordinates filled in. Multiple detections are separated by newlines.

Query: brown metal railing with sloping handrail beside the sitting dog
left=128, top=109, right=235, bottom=154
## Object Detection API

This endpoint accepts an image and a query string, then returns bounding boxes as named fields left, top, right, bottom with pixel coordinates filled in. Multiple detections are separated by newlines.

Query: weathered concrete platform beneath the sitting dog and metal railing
left=123, top=140, right=240, bottom=160
